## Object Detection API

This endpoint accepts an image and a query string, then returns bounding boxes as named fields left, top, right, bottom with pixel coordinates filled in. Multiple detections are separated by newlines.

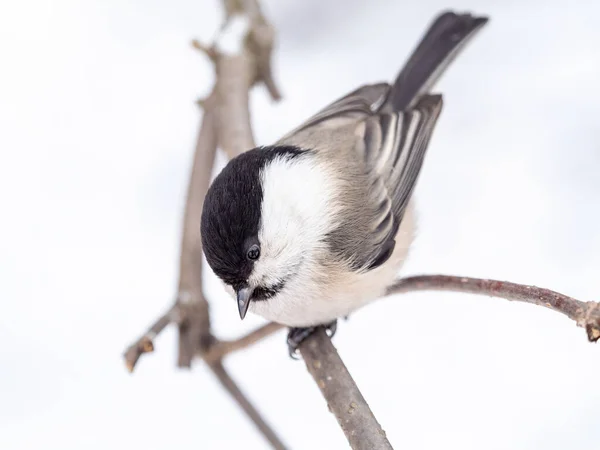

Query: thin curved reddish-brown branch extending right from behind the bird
left=387, top=275, right=600, bottom=342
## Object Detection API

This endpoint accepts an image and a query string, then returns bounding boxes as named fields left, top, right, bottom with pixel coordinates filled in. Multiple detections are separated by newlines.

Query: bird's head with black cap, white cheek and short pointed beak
left=201, top=146, right=331, bottom=319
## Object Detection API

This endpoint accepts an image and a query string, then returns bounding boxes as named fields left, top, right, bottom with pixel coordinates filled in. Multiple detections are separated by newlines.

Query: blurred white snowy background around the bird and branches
left=0, top=0, right=600, bottom=450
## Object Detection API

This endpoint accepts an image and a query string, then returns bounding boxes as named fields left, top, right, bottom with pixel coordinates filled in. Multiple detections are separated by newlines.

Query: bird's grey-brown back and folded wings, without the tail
left=279, top=90, right=442, bottom=270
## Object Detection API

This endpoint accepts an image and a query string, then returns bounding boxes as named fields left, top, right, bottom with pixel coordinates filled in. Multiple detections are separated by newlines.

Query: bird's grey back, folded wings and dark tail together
left=279, top=12, right=487, bottom=271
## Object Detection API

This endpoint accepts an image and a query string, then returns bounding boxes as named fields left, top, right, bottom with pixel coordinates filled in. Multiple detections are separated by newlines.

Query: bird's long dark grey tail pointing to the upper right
left=388, top=12, right=488, bottom=111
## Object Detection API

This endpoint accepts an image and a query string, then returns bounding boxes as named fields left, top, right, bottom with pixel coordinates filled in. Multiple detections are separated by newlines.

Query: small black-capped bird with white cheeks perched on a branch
left=200, top=11, right=488, bottom=356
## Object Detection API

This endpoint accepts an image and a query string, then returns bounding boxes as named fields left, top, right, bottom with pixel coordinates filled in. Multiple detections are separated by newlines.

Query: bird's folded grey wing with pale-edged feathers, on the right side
left=332, top=95, right=442, bottom=270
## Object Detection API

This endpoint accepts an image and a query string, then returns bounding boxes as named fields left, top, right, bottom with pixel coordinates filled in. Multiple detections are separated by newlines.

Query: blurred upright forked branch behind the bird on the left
left=124, top=0, right=285, bottom=449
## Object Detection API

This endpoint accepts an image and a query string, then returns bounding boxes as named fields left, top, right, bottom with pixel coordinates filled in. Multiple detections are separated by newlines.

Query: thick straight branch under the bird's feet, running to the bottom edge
left=299, top=328, right=392, bottom=450
